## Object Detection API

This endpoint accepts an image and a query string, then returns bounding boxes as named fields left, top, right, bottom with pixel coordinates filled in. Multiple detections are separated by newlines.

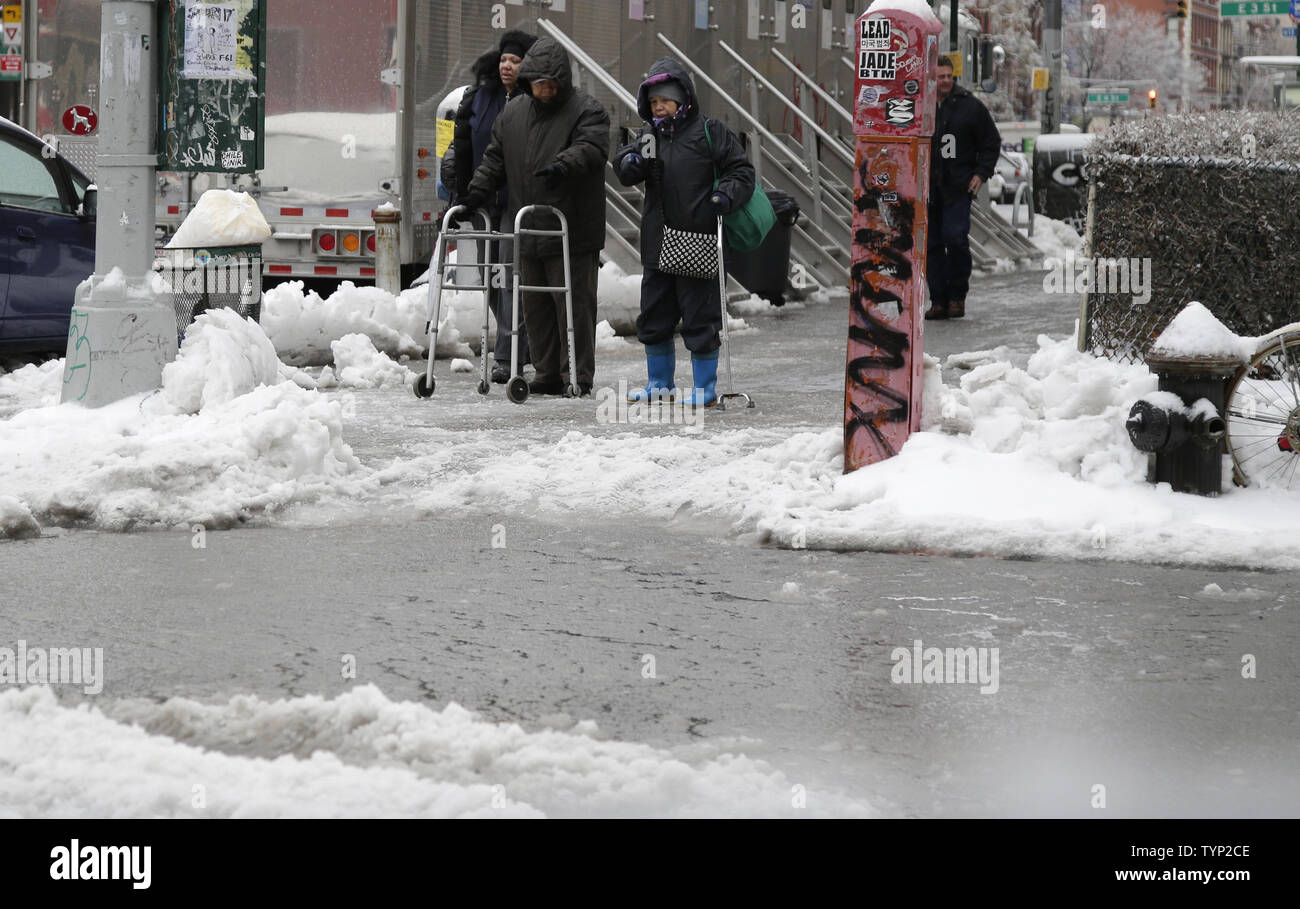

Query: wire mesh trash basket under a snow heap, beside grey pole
left=153, top=246, right=261, bottom=336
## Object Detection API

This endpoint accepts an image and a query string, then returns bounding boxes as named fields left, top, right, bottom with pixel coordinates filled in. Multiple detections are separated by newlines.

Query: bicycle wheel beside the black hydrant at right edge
left=1226, top=324, right=1300, bottom=489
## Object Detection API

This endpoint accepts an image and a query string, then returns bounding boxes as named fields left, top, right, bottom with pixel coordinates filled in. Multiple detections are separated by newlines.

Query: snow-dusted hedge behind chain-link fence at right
left=1080, top=153, right=1300, bottom=362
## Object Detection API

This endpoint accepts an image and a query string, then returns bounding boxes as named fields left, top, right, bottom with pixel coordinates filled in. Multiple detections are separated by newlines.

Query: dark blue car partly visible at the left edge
left=0, top=117, right=95, bottom=354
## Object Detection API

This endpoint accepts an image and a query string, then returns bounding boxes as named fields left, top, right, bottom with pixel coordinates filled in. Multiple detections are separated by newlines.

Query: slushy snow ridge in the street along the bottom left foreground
left=0, top=685, right=876, bottom=818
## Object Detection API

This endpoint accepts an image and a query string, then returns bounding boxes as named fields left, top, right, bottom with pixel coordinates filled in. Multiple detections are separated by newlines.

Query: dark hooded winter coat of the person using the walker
left=469, top=38, right=610, bottom=256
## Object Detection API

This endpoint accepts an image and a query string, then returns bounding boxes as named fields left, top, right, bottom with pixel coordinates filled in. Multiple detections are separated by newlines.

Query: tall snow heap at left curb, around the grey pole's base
left=0, top=310, right=361, bottom=531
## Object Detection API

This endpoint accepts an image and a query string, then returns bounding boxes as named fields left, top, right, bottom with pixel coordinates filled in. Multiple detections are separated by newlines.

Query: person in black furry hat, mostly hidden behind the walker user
left=441, top=29, right=537, bottom=384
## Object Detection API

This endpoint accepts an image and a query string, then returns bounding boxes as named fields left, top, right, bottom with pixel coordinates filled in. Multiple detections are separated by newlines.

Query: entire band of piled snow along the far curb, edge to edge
left=0, top=308, right=1300, bottom=568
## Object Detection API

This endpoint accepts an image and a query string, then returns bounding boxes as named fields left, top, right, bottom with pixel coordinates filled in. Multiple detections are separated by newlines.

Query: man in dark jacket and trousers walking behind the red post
left=926, top=57, right=1002, bottom=319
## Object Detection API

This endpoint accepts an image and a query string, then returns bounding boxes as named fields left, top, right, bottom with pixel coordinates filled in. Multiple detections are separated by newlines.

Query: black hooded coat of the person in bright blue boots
left=614, top=57, right=754, bottom=268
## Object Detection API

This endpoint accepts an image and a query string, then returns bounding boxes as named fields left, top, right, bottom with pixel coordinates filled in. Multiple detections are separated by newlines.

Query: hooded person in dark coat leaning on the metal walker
left=462, top=38, right=610, bottom=394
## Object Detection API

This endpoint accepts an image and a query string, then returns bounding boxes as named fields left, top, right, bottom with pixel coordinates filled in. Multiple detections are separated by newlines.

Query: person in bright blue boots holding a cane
left=614, top=57, right=754, bottom=407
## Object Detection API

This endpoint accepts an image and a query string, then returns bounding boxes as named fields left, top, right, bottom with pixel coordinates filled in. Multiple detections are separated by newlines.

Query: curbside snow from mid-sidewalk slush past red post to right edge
left=395, top=337, right=1300, bottom=568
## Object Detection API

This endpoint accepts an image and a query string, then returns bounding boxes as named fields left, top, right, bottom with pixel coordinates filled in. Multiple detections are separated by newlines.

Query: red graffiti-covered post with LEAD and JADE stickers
left=844, top=0, right=941, bottom=473
